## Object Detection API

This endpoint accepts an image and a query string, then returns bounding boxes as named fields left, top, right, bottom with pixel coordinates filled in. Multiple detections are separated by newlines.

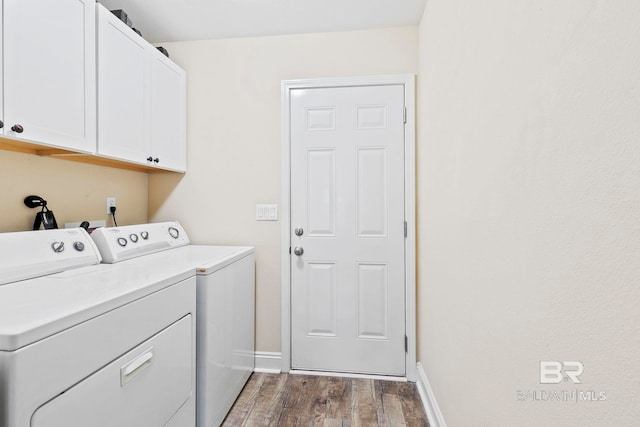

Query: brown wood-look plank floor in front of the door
left=223, top=373, right=429, bottom=427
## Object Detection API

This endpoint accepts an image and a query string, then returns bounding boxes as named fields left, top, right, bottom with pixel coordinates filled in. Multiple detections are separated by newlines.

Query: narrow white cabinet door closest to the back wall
left=149, top=53, right=187, bottom=171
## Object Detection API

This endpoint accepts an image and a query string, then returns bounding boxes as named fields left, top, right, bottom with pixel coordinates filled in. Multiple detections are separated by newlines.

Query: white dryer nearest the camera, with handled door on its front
left=0, top=229, right=196, bottom=427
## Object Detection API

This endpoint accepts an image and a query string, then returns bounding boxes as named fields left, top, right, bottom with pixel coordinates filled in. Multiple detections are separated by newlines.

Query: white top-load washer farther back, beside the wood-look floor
left=91, top=221, right=255, bottom=427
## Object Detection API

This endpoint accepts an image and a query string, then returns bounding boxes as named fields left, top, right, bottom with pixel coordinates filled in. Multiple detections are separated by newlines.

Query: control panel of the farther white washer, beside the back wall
left=91, top=221, right=190, bottom=264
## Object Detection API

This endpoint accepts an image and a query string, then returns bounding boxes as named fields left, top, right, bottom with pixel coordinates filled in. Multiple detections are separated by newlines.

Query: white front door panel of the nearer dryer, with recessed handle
left=31, top=315, right=194, bottom=427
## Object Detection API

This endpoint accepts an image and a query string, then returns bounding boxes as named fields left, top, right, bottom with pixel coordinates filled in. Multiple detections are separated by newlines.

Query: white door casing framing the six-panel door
left=280, top=74, right=417, bottom=382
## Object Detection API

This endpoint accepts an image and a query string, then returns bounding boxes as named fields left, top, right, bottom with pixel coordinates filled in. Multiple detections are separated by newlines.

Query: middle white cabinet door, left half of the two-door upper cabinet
left=98, top=6, right=150, bottom=164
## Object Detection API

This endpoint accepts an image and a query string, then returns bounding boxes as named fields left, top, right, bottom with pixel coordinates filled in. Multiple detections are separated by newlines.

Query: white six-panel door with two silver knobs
left=290, top=85, right=405, bottom=376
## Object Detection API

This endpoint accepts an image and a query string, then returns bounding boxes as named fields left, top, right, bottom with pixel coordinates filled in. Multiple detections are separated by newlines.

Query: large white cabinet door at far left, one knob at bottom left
left=4, top=0, right=96, bottom=152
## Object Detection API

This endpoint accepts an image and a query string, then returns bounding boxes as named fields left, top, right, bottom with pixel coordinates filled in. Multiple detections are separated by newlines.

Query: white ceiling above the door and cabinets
left=98, top=0, right=427, bottom=43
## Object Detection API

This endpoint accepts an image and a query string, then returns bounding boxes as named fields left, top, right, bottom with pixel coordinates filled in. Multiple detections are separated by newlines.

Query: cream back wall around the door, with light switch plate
left=149, top=27, right=417, bottom=352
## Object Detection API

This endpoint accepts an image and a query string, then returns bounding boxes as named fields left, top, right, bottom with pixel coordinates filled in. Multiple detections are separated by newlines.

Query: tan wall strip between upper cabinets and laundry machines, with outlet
left=0, top=151, right=148, bottom=232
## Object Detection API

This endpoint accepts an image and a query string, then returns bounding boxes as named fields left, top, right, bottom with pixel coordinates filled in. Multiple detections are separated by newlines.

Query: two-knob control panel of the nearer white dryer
left=0, top=228, right=102, bottom=285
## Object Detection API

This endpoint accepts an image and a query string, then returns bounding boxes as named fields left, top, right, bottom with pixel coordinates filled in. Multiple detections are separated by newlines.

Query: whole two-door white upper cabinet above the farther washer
left=98, top=5, right=186, bottom=172
